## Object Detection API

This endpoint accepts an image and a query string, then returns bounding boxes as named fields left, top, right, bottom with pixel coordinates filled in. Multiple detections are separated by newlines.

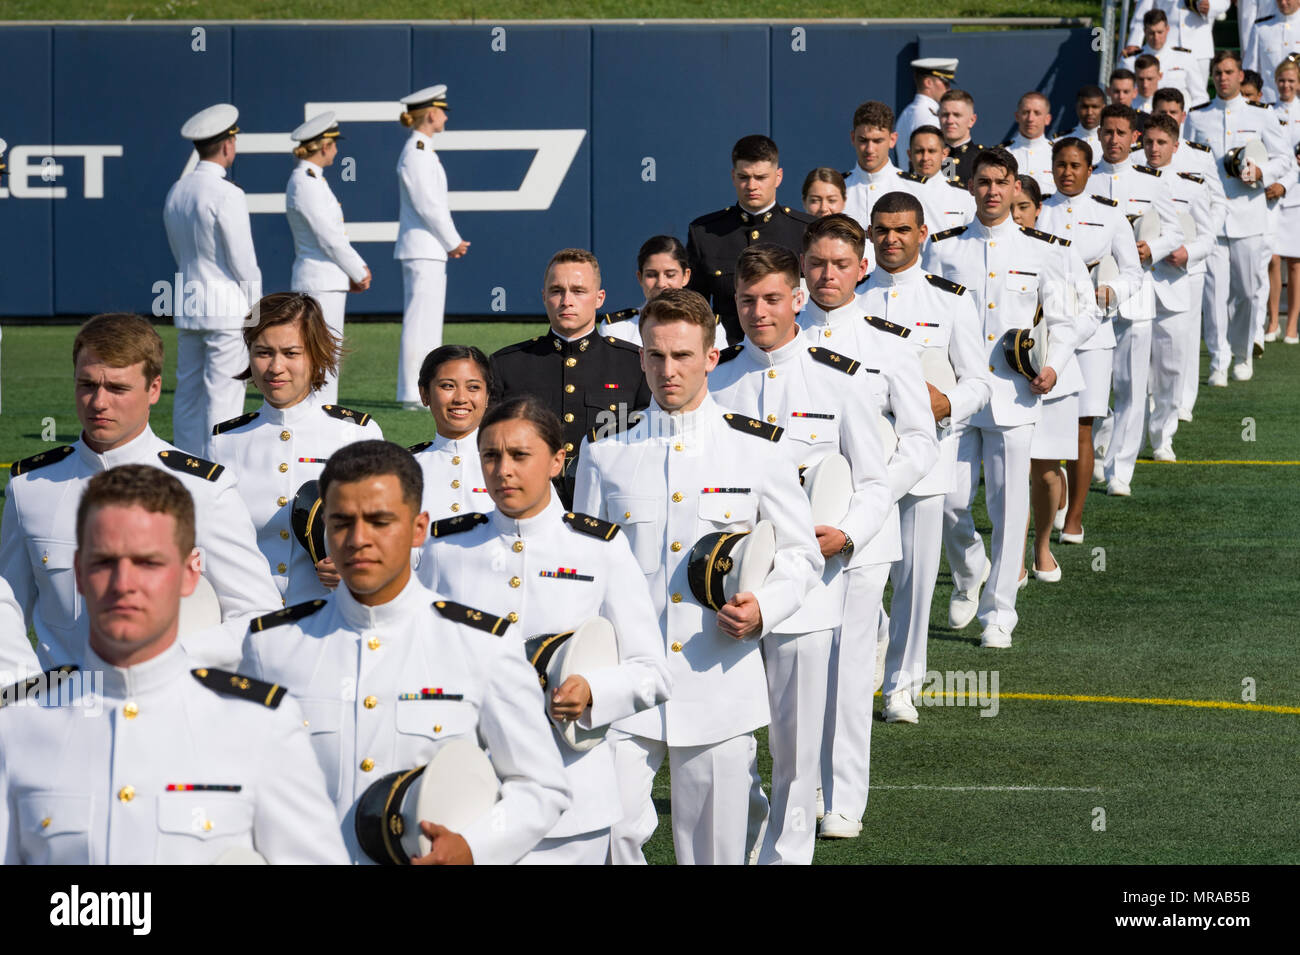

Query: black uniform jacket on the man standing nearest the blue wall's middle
left=686, top=204, right=813, bottom=344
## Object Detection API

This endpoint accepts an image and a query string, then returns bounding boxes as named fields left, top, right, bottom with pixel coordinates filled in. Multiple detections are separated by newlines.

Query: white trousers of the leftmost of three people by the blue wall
left=172, top=327, right=248, bottom=453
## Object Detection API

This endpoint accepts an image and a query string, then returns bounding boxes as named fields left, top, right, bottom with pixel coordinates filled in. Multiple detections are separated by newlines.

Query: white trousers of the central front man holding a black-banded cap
left=608, top=730, right=758, bottom=865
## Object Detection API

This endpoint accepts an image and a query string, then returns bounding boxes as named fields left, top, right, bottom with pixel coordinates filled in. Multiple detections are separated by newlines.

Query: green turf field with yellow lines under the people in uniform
left=0, top=324, right=1300, bottom=864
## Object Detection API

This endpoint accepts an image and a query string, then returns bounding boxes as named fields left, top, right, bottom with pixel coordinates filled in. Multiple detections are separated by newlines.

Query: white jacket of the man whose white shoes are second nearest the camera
left=847, top=262, right=989, bottom=495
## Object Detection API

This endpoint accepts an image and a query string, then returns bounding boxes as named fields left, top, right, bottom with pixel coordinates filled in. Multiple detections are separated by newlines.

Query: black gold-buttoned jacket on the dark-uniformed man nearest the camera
left=490, top=328, right=650, bottom=509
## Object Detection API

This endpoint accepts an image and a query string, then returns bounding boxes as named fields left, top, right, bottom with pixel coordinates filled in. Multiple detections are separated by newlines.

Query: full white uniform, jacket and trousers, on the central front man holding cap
left=573, top=395, right=823, bottom=865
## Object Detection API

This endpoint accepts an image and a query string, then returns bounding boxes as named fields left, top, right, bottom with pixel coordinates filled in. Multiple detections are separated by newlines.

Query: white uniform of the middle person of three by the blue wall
left=285, top=160, right=365, bottom=404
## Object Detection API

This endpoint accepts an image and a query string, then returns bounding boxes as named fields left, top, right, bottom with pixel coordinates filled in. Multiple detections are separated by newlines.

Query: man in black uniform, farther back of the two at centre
left=686, top=135, right=813, bottom=344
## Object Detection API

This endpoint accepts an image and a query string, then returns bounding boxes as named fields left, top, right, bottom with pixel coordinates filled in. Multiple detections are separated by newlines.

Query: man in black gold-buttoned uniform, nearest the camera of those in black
left=490, top=248, right=650, bottom=508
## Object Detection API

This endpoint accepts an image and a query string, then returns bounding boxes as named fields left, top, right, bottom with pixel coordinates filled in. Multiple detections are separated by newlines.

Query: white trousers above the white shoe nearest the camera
left=822, top=564, right=889, bottom=820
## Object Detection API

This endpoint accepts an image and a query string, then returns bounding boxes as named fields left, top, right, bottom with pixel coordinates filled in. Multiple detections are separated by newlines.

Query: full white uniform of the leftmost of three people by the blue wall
left=163, top=161, right=261, bottom=448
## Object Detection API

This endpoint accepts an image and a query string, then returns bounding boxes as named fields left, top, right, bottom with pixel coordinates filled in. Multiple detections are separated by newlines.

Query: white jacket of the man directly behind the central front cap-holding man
left=709, top=332, right=899, bottom=633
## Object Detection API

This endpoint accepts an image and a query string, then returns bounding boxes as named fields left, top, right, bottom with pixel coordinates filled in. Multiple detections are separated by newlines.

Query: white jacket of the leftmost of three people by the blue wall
left=163, top=161, right=261, bottom=331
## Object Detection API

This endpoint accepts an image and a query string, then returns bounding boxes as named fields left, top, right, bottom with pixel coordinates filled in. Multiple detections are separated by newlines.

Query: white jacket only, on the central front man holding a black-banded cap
left=573, top=395, right=823, bottom=746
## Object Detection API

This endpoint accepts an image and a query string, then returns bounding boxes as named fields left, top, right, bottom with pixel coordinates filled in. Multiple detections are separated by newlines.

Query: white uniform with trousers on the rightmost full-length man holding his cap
left=1175, top=94, right=1295, bottom=368
